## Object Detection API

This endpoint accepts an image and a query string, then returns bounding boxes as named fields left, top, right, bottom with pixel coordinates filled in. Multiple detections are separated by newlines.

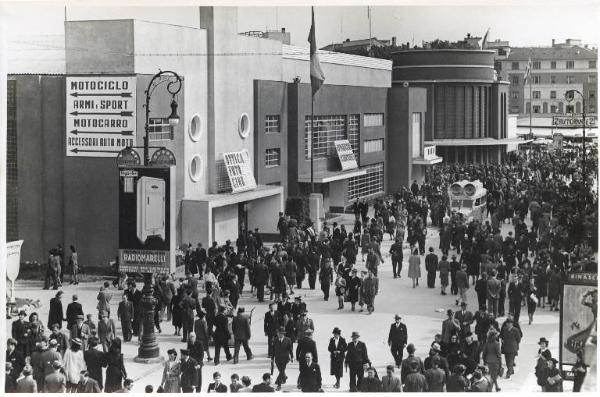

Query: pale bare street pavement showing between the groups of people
left=7, top=215, right=572, bottom=392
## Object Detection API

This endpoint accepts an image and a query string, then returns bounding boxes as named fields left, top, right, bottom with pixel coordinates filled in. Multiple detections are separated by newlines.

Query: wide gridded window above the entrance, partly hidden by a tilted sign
left=304, top=115, right=348, bottom=160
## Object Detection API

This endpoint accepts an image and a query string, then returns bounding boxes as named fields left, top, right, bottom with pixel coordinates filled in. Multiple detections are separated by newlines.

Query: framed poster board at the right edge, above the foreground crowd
left=560, top=273, right=598, bottom=379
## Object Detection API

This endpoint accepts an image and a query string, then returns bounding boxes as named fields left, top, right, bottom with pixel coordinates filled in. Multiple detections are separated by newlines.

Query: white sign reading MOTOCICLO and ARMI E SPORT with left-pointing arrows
left=65, top=76, right=136, bottom=157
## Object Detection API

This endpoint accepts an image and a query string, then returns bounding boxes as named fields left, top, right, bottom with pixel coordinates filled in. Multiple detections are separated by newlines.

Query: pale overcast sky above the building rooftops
left=0, top=0, right=600, bottom=47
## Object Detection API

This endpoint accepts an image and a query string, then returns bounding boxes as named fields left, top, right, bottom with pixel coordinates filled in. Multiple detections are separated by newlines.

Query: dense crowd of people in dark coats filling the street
left=6, top=143, right=597, bottom=392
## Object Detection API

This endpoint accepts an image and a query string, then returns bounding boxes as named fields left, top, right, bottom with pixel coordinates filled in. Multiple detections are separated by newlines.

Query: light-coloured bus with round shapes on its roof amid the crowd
left=448, top=180, right=487, bottom=221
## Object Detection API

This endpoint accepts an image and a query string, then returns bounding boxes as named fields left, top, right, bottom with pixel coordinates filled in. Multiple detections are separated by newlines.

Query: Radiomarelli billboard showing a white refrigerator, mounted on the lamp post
left=119, top=166, right=175, bottom=273
